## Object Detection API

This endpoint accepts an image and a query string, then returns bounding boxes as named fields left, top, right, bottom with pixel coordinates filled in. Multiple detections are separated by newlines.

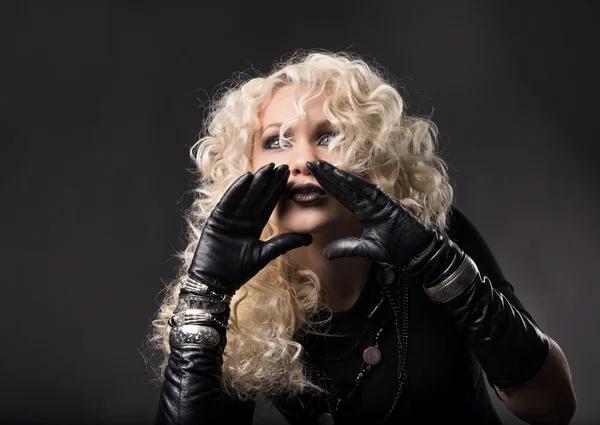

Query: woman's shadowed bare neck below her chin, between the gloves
left=287, top=234, right=373, bottom=313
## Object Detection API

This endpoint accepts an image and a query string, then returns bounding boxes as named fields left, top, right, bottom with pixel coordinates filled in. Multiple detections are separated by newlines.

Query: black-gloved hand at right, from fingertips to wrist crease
left=306, top=160, right=436, bottom=266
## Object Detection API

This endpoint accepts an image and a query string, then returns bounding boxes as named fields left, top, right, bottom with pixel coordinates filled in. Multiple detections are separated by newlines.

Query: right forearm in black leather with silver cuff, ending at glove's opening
left=409, top=236, right=548, bottom=388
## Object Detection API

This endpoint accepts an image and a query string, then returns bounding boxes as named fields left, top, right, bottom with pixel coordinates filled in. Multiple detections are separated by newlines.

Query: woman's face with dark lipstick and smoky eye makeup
left=252, top=85, right=362, bottom=235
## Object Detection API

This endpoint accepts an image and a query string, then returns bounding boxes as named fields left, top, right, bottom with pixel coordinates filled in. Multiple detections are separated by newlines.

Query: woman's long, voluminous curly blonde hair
left=150, top=51, right=453, bottom=400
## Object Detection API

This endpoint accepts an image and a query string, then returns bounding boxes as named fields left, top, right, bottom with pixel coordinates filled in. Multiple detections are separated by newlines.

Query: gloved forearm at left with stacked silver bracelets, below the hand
left=156, top=282, right=254, bottom=425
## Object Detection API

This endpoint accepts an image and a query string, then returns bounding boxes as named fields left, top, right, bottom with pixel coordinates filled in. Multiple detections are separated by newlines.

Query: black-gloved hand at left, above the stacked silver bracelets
left=188, top=163, right=312, bottom=295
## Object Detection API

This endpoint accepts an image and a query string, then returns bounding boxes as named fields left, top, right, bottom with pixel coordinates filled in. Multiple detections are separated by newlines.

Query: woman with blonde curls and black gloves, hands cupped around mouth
left=154, top=53, right=575, bottom=424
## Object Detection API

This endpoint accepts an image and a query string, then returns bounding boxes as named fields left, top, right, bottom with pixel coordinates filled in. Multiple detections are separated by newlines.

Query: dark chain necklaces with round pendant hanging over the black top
left=315, top=269, right=408, bottom=425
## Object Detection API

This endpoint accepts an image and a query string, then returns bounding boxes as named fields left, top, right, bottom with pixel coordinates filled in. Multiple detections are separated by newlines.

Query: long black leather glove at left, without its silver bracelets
left=155, top=163, right=312, bottom=425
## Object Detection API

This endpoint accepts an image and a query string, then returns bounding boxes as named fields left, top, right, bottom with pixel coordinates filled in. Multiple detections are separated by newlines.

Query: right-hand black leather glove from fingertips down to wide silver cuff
left=306, top=160, right=464, bottom=287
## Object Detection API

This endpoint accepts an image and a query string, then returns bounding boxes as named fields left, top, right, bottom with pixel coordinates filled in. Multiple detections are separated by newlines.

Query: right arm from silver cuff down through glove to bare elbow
left=412, top=241, right=575, bottom=424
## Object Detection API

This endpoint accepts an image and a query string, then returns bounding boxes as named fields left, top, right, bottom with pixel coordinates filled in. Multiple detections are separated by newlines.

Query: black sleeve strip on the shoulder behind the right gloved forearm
left=448, top=208, right=539, bottom=328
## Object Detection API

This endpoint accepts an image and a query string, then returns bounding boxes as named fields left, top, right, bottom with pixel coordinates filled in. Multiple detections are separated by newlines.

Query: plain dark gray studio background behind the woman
left=0, top=0, right=600, bottom=424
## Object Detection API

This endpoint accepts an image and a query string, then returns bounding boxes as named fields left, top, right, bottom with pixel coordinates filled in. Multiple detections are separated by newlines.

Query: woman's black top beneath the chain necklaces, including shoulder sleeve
left=231, top=209, right=535, bottom=425
